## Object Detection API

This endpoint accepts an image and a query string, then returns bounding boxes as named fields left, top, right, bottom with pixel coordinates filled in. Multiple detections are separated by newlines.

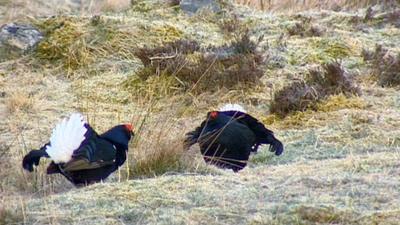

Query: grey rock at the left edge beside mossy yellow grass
left=0, top=23, right=43, bottom=61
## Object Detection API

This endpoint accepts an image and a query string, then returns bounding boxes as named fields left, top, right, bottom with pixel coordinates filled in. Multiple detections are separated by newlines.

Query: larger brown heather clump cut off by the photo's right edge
left=361, top=45, right=400, bottom=87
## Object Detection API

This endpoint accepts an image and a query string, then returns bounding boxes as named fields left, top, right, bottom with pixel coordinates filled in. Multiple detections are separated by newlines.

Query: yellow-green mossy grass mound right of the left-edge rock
left=35, top=16, right=134, bottom=71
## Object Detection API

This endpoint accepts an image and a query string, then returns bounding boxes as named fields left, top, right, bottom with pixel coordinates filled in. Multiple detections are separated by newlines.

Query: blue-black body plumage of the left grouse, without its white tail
left=22, top=123, right=134, bottom=186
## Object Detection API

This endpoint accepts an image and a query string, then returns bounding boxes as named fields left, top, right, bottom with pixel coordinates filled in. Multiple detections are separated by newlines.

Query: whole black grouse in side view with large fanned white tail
left=22, top=113, right=134, bottom=186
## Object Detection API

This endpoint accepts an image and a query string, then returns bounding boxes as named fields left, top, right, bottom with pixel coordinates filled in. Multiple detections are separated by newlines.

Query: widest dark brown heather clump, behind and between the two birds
left=131, top=31, right=264, bottom=94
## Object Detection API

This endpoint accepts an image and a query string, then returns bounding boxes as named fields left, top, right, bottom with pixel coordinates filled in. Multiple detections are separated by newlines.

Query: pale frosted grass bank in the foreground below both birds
left=27, top=153, right=400, bottom=224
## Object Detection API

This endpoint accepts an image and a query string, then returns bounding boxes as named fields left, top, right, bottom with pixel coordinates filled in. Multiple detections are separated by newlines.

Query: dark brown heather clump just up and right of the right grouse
left=270, top=62, right=361, bottom=117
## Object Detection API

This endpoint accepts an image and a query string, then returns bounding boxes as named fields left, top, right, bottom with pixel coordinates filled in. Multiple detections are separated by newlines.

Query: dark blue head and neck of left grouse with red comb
left=100, top=123, right=134, bottom=150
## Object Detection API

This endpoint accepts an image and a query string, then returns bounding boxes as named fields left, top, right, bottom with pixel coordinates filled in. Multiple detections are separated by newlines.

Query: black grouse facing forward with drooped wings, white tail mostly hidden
left=184, top=104, right=283, bottom=172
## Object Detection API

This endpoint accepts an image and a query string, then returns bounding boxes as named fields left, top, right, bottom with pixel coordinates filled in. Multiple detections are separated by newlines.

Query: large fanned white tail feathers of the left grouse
left=46, top=113, right=87, bottom=163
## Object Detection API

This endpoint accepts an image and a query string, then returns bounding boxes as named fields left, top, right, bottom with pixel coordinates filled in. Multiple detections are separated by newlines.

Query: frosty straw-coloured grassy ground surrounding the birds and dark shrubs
left=0, top=1, right=400, bottom=224
